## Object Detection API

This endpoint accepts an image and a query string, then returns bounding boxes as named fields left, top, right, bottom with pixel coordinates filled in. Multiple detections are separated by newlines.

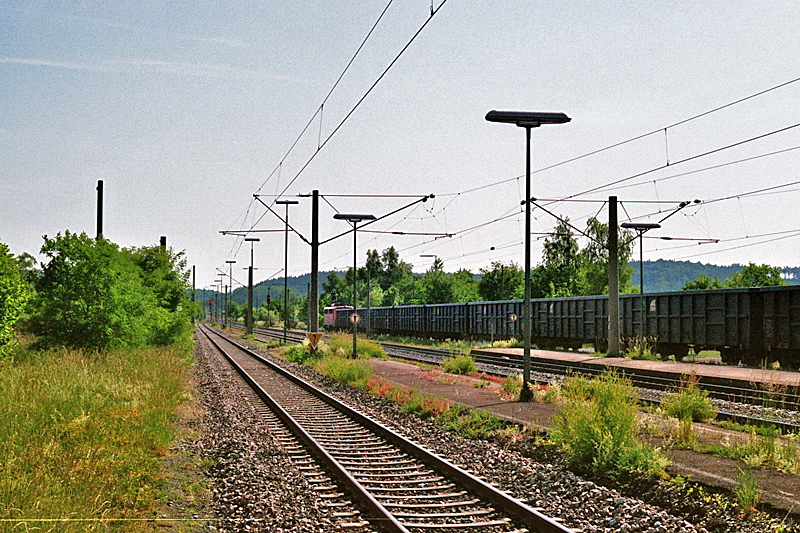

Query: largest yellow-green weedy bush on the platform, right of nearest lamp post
left=551, top=372, right=666, bottom=480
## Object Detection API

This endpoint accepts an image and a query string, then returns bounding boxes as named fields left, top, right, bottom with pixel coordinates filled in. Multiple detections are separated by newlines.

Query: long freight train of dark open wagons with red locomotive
left=325, top=285, right=800, bottom=368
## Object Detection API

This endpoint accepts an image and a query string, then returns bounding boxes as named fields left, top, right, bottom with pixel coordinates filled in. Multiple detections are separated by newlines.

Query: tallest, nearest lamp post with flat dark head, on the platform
left=486, top=111, right=572, bottom=394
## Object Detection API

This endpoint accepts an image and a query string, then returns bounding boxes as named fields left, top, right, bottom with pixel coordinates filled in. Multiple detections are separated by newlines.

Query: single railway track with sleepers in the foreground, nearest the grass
left=202, top=327, right=572, bottom=533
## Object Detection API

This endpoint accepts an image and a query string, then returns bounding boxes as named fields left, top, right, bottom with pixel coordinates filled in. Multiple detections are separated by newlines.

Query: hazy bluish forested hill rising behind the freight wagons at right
left=631, top=259, right=800, bottom=292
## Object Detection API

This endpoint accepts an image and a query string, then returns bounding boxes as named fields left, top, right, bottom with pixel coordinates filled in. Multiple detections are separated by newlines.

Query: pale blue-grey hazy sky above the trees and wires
left=0, top=0, right=800, bottom=288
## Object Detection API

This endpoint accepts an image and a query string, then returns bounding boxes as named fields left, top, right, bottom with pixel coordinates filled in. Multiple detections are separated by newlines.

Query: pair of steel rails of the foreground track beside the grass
left=204, top=328, right=574, bottom=533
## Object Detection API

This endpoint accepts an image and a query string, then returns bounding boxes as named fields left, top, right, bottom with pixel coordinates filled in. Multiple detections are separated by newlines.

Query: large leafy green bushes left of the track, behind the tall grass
left=31, top=231, right=191, bottom=349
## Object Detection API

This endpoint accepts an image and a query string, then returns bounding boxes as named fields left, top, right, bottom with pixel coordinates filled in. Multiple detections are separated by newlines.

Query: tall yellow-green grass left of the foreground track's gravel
left=0, top=340, right=189, bottom=532
